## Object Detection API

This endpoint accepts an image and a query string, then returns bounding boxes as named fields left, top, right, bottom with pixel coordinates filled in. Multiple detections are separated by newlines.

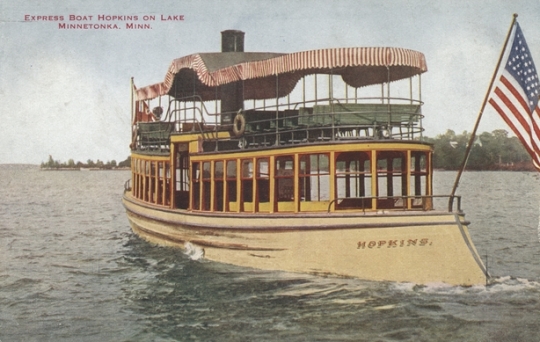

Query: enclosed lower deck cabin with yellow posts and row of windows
left=130, top=140, right=437, bottom=213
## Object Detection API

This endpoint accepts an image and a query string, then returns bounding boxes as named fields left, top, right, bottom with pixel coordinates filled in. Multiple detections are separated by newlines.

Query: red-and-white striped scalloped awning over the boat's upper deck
left=137, top=47, right=427, bottom=101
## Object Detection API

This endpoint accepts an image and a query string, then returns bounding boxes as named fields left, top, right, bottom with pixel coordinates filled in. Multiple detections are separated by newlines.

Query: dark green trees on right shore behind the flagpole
left=424, top=129, right=535, bottom=171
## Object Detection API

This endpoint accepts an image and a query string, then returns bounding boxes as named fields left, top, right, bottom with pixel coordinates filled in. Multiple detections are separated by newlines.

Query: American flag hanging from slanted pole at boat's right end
left=489, top=22, right=540, bottom=171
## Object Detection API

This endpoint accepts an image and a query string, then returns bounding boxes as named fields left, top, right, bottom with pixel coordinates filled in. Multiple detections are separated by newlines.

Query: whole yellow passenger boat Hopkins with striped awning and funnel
left=123, top=30, right=489, bottom=286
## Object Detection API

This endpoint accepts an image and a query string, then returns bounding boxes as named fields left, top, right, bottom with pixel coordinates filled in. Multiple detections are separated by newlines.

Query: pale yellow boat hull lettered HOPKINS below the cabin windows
left=123, top=192, right=488, bottom=286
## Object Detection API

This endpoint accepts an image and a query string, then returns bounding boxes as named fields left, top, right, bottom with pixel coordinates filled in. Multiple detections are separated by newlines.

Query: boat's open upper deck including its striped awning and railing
left=131, top=31, right=427, bottom=153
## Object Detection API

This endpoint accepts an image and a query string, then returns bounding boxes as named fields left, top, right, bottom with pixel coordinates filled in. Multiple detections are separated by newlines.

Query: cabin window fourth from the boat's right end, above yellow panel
left=299, top=154, right=330, bottom=202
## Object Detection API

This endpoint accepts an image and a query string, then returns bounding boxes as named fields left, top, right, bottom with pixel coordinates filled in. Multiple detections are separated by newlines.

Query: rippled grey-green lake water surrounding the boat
left=0, top=165, right=540, bottom=342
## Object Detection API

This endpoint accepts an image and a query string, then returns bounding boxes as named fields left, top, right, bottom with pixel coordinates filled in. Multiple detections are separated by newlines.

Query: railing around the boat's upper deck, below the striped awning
left=137, top=96, right=423, bottom=150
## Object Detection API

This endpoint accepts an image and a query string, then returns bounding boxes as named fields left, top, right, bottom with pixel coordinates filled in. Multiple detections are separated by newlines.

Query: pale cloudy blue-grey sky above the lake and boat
left=0, top=0, right=540, bottom=164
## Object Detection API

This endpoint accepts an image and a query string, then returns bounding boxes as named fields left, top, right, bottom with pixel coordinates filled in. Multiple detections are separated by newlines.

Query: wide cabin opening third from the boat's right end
left=336, top=152, right=373, bottom=209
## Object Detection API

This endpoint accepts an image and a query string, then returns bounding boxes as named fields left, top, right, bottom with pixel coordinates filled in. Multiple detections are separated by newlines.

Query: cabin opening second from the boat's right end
left=377, top=151, right=407, bottom=209
